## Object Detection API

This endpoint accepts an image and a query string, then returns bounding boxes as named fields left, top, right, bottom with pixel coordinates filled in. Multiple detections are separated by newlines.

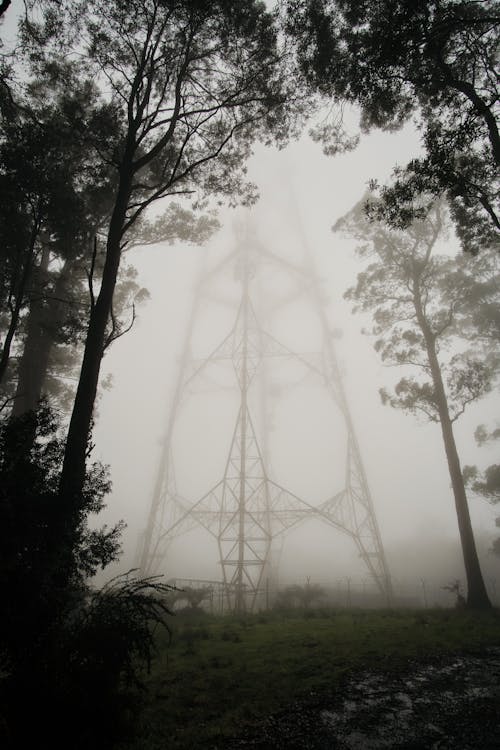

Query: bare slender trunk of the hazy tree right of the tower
left=414, top=280, right=491, bottom=609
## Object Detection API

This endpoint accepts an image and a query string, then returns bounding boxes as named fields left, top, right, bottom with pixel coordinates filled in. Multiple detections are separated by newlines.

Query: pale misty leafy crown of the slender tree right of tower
left=334, top=200, right=500, bottom=422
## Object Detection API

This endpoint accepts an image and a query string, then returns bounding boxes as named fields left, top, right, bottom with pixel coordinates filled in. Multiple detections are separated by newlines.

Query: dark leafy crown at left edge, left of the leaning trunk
left=0, top=64, right=116, bottom=396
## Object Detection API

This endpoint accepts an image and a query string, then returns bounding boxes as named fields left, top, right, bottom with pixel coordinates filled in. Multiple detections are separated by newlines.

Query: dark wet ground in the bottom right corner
left=226, top=649, right=500, bottom=750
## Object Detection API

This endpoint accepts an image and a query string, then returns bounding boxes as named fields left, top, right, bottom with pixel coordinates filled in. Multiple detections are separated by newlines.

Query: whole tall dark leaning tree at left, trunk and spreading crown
left=19, top=0, right=300, bottom=508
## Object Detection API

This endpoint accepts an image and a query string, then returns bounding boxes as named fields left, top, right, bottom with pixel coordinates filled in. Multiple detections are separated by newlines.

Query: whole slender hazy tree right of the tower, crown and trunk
left=334, top=197, right=496, bottom=608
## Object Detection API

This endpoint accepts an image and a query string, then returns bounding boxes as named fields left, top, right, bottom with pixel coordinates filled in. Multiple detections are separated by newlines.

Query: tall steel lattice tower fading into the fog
left=139, top=223, right=392, bottom=612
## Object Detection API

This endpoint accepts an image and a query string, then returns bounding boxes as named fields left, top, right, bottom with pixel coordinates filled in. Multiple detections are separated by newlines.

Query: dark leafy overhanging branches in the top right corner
left=287, top=0, right=500, bottom=253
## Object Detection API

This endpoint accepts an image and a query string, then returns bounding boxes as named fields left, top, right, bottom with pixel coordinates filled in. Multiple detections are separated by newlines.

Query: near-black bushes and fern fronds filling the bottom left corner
left=0, top=407, right=174, bottom=750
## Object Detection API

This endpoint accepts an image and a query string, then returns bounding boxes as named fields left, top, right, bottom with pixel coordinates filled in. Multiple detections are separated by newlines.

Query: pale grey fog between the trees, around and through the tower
left=94, top=123, right=500, bottom=599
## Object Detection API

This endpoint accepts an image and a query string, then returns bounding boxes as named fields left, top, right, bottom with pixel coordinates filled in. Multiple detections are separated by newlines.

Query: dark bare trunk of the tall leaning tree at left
left=59, top=170, right=132, bottom=510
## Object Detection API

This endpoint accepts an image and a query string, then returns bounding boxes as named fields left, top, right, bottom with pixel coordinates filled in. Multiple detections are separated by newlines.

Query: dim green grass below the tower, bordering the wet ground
left=120, top=610, right=500, bottom=750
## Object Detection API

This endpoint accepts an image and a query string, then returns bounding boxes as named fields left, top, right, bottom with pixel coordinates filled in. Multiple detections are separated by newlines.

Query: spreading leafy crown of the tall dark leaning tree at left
left=29, top=0, right=302, bottom=217
